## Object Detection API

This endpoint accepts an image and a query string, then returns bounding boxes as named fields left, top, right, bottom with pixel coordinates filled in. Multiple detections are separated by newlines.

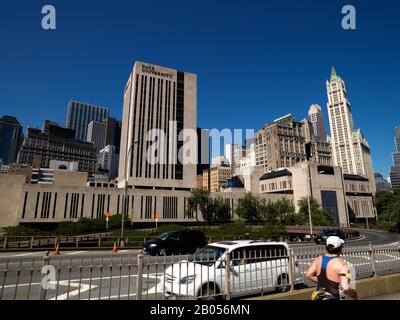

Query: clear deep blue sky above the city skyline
left=0, top=0, right=400, bottom=176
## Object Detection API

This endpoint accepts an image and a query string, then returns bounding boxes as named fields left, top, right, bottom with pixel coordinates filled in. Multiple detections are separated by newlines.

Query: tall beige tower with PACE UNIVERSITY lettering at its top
left=118, top=62, right=197, bottom=190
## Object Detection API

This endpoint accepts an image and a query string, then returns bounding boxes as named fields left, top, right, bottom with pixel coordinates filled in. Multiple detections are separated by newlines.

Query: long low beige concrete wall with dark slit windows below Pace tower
left=0, top=175, right=291, bottom=227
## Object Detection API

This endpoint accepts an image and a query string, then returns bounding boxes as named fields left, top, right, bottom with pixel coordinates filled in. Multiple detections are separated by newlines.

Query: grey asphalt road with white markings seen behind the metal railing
left=0, top=231, right=400, bottom=300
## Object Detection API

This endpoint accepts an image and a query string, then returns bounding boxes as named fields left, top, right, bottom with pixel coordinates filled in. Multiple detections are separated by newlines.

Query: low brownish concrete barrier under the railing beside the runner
left=246, top=274, right=400, bottom=300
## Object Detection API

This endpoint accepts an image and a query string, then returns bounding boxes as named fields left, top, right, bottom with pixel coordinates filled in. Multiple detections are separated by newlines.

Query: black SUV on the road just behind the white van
left=143, top=230, right=207, bottom=256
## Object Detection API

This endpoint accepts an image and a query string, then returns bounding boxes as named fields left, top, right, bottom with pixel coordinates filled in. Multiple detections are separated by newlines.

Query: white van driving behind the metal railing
left=161, top=240, right=298, bottom=299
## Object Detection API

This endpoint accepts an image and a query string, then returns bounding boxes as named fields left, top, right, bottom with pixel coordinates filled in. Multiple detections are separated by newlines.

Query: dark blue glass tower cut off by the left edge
left=0, top=116, right=22, bottom=165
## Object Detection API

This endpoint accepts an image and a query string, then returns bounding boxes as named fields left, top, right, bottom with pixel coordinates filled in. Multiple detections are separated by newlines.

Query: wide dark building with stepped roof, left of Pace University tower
left=18, top=121, right=96, bottom=173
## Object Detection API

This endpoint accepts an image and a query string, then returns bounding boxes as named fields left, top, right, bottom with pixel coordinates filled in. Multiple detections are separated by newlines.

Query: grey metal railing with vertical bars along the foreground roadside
left=0, top=242, right=400, bottom=300
